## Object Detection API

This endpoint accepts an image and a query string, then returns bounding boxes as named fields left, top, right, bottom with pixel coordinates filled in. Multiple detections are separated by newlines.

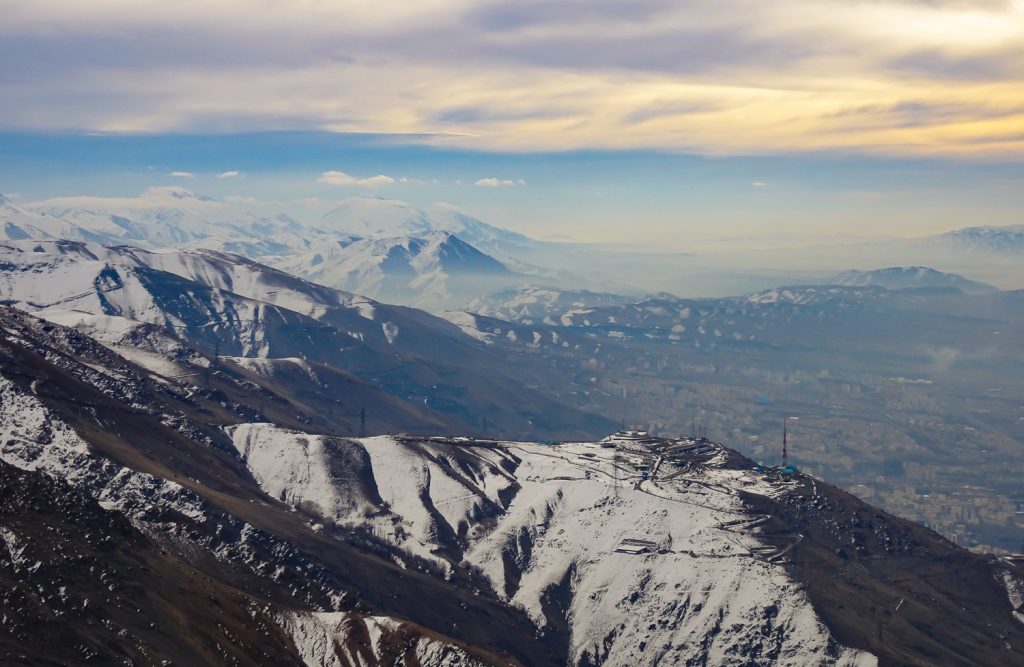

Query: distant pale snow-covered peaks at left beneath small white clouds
left=6, top=186, right=545, bottom=308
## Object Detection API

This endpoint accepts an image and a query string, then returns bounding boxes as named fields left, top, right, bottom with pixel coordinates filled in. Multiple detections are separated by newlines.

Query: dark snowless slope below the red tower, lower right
left=745, top=480, right=1024, bottom=665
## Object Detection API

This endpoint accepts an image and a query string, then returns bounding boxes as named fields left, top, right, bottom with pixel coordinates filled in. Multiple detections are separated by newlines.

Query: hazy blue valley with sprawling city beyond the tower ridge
left=449, top=287, right=1024, bottom=551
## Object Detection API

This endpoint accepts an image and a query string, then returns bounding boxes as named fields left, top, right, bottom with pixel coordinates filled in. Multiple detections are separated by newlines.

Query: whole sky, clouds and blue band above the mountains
left=0, top=0, right=1024, bottom=247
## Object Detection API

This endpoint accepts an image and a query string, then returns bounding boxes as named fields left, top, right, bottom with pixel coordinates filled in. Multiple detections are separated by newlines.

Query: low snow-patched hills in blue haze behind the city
left=456, top=285, right=1024, bottom=356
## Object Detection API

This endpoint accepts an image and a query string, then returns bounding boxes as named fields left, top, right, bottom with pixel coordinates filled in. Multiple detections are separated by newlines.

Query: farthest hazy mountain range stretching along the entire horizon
left=0, top=186, right=1024, bottom=311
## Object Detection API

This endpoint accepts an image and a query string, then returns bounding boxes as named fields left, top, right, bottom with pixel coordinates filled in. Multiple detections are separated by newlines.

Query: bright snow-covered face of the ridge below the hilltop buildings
left=231, top=424, right=876, bottom=665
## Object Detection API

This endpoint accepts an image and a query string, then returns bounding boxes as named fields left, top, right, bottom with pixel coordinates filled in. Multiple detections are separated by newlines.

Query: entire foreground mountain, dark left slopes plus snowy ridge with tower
left=0, top=307, right=1024, bottom=667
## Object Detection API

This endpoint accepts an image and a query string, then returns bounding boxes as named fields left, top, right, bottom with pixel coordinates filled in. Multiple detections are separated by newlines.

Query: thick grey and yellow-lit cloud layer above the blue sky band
left=0, top=0, right=1024, bottom=156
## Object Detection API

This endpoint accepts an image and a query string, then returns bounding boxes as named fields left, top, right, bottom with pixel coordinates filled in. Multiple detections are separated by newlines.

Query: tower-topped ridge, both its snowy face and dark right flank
left=226, top=424, right=1024, bottom=665
